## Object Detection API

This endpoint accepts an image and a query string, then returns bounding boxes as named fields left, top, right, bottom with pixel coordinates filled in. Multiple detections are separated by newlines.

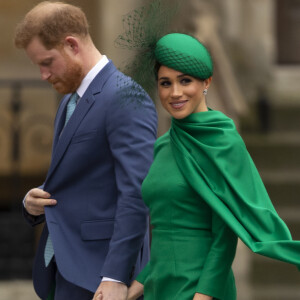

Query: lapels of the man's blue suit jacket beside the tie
left=46, top=61, right=116, bottom=182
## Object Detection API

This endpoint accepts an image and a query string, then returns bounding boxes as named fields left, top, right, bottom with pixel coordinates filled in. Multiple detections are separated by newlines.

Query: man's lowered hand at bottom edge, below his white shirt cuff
left=93, top=281, right=128, bottom=300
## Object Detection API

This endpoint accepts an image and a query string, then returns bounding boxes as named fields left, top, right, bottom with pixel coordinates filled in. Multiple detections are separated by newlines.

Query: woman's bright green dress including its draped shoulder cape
left=137, top=110, right=300, bottom=300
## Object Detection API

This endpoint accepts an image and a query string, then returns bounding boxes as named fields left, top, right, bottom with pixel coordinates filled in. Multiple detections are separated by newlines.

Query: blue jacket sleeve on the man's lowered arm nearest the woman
left=101, top=83, right=157, bottom=285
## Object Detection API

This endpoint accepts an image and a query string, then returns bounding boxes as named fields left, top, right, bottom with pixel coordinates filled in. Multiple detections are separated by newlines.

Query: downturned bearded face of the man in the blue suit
left=25, top=37, right=84, bottom=94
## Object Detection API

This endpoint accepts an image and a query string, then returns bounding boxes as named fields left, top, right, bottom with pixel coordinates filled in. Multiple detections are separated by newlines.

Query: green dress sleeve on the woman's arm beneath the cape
left=196, top=213, right=237, bottom=299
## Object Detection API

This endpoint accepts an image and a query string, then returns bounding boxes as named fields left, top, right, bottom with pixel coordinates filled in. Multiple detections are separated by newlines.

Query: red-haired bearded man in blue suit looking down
left=15, top=1, right=157, bottom=300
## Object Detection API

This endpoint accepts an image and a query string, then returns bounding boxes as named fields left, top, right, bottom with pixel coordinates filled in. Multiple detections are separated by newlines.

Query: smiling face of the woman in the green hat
left=158, top=66, right=211, bottom=119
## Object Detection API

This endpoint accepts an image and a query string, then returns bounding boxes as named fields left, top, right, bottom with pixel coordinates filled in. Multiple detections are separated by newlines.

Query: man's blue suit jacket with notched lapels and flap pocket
left=25, top=62, right=157, bottom=299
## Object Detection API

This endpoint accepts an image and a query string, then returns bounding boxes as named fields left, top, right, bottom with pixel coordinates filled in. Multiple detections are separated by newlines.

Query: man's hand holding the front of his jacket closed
left=24, top=188, right=57, bottom=216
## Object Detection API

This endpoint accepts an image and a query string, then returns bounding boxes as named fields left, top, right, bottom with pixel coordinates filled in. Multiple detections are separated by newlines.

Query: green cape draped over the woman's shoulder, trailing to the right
left=170, top=110, right=300, bottom=269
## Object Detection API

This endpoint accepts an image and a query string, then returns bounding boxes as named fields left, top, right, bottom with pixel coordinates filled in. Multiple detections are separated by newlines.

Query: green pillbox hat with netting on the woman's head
left=155, top=33, right=213, bottom=79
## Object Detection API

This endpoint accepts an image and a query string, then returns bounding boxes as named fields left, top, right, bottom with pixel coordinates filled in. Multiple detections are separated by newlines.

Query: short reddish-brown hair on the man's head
left=15, top=1, right=89, bottom=49
